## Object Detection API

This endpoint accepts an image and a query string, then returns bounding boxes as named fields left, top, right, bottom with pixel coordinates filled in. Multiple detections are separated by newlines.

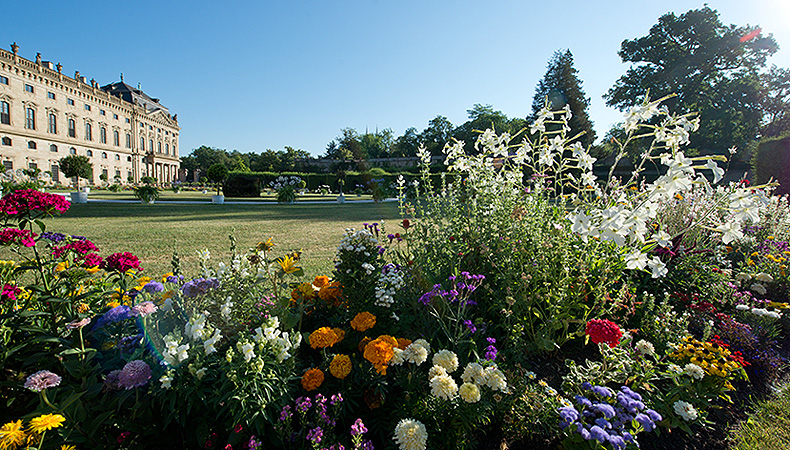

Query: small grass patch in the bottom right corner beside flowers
left=730, top=383, right=790, bottom=450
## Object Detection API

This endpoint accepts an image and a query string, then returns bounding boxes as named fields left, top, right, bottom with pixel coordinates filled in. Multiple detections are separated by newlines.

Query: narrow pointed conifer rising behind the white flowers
left=530, top=50, right=595, bottom=148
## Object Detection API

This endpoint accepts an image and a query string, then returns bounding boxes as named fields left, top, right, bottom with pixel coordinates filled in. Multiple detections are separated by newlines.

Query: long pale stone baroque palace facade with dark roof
left=0, top=43, right=181, bottom=184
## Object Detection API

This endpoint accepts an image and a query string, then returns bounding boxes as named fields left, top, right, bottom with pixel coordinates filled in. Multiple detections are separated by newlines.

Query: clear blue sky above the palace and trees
left=0, top=0, right=790, bottom=156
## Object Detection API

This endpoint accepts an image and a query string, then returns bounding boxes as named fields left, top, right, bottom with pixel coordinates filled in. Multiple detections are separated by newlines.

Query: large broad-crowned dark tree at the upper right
left=604, top=7, right=778, bottom=158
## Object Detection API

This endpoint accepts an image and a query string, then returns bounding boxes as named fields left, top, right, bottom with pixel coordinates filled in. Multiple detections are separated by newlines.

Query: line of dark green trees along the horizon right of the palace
left=182, top=6, right=790, bottom=178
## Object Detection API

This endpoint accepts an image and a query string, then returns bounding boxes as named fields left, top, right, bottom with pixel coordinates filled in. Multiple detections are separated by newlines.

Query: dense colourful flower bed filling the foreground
left=0, top=96, right=790, bottom=450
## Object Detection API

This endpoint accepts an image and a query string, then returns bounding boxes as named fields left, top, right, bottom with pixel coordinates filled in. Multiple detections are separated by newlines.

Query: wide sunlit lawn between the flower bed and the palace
left=19, top=201, right=398, bottom=275
